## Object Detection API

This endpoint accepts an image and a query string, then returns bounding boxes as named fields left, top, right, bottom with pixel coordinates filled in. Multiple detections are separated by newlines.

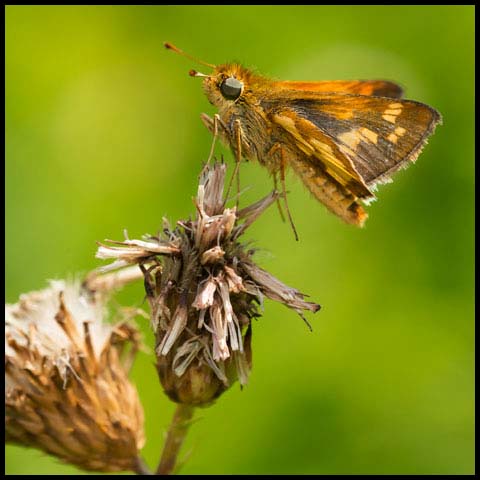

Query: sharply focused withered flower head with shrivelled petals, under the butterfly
left=97, top=163, right=320, bottom=406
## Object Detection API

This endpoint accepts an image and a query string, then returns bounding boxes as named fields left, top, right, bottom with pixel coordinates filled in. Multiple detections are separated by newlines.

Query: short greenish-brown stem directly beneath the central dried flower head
left=156, top=403, right=194, bottom=475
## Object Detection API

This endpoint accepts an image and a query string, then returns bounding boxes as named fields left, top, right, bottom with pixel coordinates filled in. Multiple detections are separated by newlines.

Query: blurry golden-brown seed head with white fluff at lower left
left=5, top=278, right=144, bottom=472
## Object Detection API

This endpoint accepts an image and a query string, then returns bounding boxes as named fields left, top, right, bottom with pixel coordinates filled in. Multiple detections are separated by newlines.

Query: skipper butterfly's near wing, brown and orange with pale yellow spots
left=270, top=93, right=441, bottom=191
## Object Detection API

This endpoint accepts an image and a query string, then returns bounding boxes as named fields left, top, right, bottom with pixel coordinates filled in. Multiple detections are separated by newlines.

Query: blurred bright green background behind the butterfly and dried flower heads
left=6, top=6, right=474, bottom=474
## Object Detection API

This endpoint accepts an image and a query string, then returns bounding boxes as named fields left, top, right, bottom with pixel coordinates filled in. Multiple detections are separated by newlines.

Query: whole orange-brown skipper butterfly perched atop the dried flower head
left=165, top=44, right=441, bottom=226
